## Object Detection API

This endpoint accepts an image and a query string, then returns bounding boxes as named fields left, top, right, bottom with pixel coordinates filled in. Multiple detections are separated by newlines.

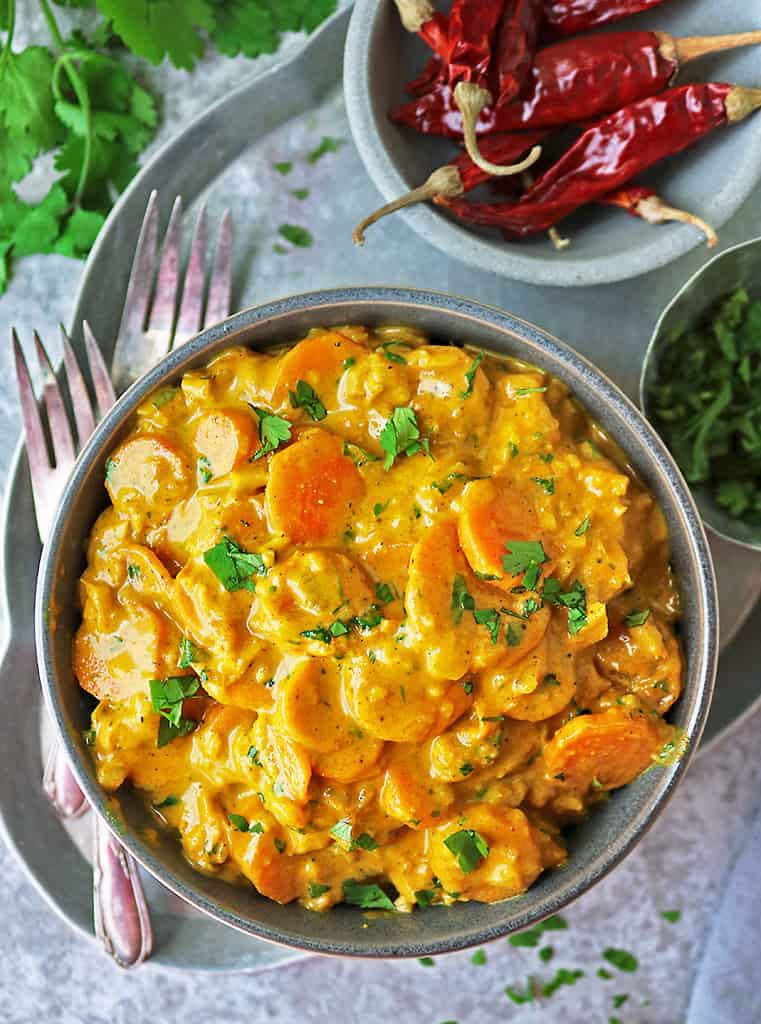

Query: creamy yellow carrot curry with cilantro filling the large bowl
left=74, top=327, right=682, bottom=910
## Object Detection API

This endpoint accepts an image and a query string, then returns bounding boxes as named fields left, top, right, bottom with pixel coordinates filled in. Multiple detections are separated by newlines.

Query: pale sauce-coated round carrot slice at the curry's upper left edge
left=105, top=434, right=191, bottom=519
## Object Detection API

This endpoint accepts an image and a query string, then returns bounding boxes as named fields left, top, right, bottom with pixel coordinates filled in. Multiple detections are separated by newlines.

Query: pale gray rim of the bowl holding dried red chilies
left=343, top=0, right=758, bottom=288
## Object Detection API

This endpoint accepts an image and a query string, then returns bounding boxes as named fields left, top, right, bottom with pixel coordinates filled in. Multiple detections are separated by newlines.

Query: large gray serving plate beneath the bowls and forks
left=0, top=0, right=761, bottom=971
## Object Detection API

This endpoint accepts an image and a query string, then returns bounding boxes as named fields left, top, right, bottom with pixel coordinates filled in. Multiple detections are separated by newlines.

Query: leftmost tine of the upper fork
left=112, top=190, right=159, bottom=390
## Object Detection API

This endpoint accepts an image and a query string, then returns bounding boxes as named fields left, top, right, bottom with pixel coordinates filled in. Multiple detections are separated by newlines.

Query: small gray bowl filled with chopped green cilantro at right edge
left=640, top=239, right=761, bottom=551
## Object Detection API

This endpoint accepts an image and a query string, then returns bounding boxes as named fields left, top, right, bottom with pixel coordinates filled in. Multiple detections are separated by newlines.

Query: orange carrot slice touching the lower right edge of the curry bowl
left=545, top=709, right=662, bottom=791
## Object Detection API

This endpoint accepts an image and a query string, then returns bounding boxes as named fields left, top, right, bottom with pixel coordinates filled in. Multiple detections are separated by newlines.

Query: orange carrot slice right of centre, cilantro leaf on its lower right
left=458, top=479, right=551, bottom=589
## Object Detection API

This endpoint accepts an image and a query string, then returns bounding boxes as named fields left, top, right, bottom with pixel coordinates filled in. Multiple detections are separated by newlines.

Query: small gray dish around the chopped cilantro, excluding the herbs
left=639, top=239, right=761, bottom=552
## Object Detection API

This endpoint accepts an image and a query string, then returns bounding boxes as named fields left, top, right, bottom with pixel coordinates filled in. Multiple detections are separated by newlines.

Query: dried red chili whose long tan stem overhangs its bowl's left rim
left=351, top=131, right=547, bottom=246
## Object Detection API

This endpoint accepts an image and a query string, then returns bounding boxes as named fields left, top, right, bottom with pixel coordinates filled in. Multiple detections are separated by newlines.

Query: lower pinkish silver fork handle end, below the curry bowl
left=92, top=814, right=154, bottom=968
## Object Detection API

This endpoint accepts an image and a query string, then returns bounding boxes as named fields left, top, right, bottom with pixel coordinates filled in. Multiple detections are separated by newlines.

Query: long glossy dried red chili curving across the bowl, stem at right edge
left=434, top=83, right=761, bottom=238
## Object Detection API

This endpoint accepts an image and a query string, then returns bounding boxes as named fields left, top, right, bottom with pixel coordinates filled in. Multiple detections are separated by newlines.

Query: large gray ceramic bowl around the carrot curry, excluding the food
left=36, top=288, right=718, bottom=956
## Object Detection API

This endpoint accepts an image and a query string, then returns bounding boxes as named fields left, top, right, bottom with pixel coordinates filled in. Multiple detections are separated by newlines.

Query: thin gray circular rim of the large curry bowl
left=35, top=286, right=718, bottom=958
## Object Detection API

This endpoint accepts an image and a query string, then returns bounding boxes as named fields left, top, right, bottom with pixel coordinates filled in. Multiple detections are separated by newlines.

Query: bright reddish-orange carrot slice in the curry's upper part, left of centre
left=265, top=430, right=365, bottom=544
